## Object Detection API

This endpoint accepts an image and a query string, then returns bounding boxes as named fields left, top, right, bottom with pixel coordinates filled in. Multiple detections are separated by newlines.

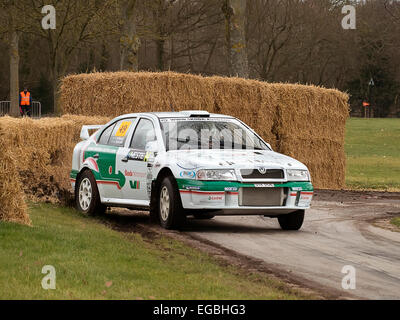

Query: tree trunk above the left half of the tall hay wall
left=120, top=0, right=140, bottom=71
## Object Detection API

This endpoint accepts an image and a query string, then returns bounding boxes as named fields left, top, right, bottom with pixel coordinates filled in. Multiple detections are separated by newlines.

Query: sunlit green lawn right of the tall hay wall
left=345, top=118, right=400, bottom=191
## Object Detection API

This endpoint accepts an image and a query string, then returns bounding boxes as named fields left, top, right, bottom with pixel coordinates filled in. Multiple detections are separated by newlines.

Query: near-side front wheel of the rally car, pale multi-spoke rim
left=157, top=177, right=186, bottom=230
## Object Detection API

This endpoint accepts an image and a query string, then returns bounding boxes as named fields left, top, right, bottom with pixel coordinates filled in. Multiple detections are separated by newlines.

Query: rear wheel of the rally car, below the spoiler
left=75, top=170, right=107, bottom=216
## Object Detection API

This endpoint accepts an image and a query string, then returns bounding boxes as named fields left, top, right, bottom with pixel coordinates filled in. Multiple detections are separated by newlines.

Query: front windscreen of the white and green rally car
left=161, top=118, right=270, bottom=151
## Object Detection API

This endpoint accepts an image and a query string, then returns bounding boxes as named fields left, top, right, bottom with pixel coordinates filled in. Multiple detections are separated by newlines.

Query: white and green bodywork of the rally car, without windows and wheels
left=71, top=112, right=313, bottom=216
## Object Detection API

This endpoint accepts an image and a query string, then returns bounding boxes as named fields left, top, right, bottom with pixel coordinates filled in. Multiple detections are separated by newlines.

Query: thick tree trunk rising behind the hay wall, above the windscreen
left=222, top=0, right=249, bottom=78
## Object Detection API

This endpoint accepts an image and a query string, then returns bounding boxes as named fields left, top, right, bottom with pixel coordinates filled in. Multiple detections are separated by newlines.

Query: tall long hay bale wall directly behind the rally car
left=61, top=72, right=349, bottom=189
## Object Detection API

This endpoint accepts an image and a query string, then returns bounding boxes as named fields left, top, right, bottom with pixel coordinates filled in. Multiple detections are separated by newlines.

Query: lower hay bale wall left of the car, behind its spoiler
left=0, top=116, right=109, bottom=211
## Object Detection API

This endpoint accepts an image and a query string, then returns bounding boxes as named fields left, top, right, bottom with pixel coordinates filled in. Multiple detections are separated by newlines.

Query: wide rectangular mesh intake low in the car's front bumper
left=239, top=188, right=287, bottom=207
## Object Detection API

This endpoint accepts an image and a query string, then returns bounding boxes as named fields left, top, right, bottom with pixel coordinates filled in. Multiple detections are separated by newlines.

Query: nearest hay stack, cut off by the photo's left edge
left=0, top=124, right=31, bottom=225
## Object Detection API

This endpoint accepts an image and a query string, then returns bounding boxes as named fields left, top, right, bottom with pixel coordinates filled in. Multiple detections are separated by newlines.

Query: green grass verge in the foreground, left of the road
left=0, top=204, right=309, bottom=299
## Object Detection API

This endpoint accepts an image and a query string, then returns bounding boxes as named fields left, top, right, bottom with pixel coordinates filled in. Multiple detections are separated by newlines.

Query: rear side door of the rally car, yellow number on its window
left=85, top=118, right=135, bottom=201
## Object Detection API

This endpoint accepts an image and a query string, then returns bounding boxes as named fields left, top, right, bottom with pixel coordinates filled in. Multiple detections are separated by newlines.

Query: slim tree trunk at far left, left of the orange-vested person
left=10, top=28, right=20, bottom=117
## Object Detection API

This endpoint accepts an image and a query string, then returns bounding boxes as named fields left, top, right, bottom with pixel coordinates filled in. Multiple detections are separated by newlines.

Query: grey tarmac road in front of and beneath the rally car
left=180, top=192, right=400, bottom=299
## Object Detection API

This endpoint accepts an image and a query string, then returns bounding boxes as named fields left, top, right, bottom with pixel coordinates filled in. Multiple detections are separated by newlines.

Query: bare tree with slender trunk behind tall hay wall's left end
left=16, top=0, right=113, bottom=113
